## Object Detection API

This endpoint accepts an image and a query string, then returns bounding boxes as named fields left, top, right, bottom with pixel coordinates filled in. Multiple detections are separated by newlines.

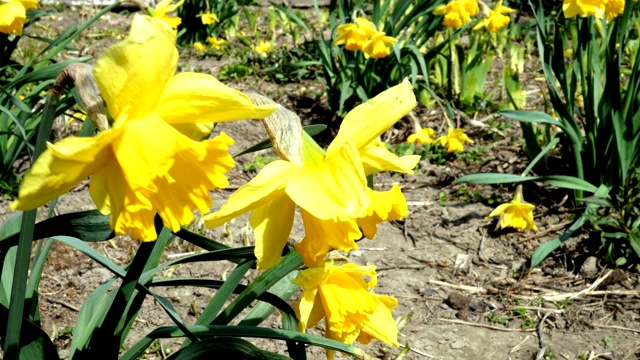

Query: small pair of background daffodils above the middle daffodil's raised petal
left=333, top=17, right=398, bottom=59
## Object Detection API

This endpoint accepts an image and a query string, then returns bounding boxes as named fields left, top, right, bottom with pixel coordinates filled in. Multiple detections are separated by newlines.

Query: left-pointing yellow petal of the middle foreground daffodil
left=203, top=160, right=299, bottom=228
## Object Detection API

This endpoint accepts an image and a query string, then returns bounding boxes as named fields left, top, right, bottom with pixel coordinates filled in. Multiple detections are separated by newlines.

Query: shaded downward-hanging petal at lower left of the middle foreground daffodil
left=250, top=193, right=296, bottom=269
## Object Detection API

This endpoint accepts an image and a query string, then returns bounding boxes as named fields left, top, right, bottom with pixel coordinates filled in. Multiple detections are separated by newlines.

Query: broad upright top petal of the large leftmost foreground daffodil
left=94, top=14, right=178, bottom=120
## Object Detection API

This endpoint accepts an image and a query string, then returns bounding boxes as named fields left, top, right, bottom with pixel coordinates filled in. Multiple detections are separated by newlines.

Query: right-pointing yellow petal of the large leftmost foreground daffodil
left=156, top=72, right=278, bottom=124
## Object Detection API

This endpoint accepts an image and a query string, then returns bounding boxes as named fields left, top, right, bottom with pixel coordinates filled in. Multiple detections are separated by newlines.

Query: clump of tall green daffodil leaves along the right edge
left=459, top=2, right=640, bottom=266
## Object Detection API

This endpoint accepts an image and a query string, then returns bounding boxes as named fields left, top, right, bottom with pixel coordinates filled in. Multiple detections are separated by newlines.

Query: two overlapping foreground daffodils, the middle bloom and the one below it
left=204, top=80, right=420, bottom=354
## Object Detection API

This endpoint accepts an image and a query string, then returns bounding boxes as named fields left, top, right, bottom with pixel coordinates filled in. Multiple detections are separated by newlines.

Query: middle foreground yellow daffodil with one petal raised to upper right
left=204, top=80, right=420, bottom=268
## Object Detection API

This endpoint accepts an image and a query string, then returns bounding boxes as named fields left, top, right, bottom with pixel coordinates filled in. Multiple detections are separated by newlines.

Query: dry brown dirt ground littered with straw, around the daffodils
left=0, top=4, right=640, bottom=359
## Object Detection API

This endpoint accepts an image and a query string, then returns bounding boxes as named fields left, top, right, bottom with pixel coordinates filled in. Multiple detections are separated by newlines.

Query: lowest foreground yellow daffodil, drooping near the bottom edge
left=292, top=262, right=399, bottom=359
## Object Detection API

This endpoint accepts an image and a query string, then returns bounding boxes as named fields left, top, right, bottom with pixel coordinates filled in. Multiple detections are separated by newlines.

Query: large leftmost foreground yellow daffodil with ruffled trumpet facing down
left=11, top=15, right=275, bottom=241
